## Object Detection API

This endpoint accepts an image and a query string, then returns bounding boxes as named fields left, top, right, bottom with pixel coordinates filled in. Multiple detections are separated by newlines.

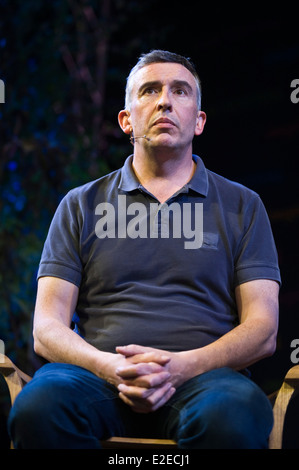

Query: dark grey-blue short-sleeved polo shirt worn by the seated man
left=38, top=155, right=280, bottom=352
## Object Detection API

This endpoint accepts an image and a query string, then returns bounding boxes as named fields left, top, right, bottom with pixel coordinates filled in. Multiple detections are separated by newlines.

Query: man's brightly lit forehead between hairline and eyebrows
left=132, top=62, right=196, bottom=89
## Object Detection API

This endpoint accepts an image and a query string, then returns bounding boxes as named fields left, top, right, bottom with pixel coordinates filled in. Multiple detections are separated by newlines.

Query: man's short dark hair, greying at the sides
left=125, top=49, right=201, bottom=109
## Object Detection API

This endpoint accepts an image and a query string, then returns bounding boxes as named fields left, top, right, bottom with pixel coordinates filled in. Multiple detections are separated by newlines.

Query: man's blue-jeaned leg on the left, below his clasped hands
left=9, top=363, right=142, bottom=448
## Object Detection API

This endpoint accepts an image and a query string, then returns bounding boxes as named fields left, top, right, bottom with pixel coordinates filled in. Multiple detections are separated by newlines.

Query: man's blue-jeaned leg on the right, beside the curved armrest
left=160, top=368, right=273, bottom=449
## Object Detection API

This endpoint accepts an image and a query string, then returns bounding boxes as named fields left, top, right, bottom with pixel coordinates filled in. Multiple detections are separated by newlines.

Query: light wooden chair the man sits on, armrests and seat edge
left=0, top=354, right=299, bottom=449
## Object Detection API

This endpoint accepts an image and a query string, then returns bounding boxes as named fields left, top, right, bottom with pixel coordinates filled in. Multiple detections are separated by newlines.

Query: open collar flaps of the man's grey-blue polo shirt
left=118, top=155, right=209, bottom=196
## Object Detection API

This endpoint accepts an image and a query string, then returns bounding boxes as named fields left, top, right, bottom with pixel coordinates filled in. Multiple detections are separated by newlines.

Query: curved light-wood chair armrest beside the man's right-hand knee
left=269, top=365, right=299, bottom=449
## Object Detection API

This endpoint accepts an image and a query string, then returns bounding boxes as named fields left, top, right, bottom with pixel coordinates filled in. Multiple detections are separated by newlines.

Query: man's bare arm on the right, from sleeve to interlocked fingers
left=117, top=280, right=279, bottom=411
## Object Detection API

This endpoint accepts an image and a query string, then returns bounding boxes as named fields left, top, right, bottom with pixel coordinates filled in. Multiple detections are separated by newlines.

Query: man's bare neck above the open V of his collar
left=132, top=147, right=196, bottom=203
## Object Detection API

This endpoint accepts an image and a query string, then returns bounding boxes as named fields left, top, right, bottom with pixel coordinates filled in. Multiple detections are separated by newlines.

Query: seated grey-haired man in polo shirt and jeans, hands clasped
left=10, top=51, right=280, bottom=448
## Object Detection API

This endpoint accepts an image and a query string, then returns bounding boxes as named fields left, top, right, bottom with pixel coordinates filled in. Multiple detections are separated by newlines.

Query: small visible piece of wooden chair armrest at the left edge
left=0, top=354, right=31, bottom=405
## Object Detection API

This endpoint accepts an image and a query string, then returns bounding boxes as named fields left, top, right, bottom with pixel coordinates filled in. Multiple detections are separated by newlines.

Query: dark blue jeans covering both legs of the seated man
left=9, top=364, right=273, bottom=449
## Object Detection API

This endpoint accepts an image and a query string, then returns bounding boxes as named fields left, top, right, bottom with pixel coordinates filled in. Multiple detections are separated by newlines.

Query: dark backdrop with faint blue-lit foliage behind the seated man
left=0, top=0, right=299, bottom=392
